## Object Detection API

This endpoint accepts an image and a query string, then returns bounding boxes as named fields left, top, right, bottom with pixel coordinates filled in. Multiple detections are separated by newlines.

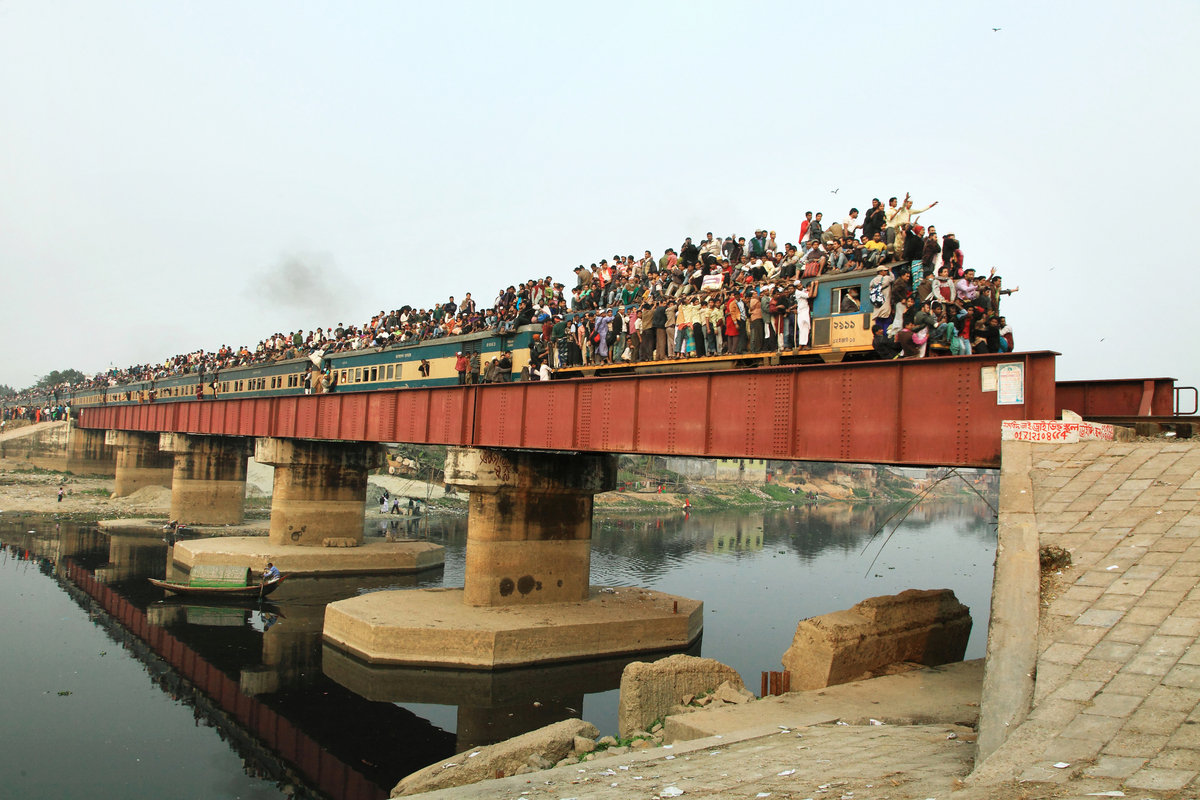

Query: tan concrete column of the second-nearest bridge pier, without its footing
left=254, top=439, right=382, bottom=547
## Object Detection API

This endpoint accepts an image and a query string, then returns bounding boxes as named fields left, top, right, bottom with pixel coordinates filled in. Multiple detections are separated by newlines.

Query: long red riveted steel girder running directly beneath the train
left=80, top=351, right=1056, bottom=467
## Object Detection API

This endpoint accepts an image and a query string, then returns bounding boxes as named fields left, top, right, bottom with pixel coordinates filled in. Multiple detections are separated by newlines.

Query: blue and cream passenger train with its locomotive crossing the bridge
left=5, top=270, right=892, bottom=409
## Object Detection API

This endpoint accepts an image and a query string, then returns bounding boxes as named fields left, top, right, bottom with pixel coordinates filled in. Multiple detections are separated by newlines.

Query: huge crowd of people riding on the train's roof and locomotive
left=7, top=194, right=1018, bottom=398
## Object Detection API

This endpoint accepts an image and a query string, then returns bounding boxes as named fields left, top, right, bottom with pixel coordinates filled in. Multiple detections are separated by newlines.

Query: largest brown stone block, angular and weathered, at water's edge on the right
left=784, top=589, right=971, bottom=691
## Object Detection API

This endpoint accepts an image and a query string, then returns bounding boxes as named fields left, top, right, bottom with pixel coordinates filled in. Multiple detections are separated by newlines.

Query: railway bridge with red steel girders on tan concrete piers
left=63, top=351, right=1190, bottom=668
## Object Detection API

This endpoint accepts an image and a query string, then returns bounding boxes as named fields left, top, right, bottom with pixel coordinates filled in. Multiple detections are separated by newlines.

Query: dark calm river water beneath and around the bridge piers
left=0, top=499, right=996, bottom=800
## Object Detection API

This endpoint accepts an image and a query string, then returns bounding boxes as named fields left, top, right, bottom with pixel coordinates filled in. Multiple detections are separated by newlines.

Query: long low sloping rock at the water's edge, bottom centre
left=391, top=720, right=600, bottom=798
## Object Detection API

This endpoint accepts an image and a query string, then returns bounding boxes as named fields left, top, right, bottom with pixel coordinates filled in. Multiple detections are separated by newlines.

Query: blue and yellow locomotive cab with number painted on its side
left=811, top=270, right=876, bottom=363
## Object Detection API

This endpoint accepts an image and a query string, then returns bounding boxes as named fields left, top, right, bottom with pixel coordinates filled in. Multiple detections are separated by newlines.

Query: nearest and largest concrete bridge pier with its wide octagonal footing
left=324, top=447, right=704, bottom=669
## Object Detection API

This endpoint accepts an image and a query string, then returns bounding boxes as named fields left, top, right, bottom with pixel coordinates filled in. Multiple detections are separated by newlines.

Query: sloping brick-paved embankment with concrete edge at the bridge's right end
left=971, top=439, right=1200, bottom=796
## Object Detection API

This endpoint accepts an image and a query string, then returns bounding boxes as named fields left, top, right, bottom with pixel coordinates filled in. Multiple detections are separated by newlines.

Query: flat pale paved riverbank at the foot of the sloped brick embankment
left=398, top=661, right=988, bottom=800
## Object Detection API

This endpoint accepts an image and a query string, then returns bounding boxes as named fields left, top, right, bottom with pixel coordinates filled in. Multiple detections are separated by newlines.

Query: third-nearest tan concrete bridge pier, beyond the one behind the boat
left=158, top=433, right=251, bottom=525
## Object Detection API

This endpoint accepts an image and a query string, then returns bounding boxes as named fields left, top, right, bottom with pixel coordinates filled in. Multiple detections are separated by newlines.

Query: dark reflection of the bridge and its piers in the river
left=0, top=524, right=455, bottom=799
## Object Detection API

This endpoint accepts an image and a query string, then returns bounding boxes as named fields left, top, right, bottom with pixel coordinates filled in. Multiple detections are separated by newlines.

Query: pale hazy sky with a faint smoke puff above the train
left=0, top=0, right=1200, bottom=400
